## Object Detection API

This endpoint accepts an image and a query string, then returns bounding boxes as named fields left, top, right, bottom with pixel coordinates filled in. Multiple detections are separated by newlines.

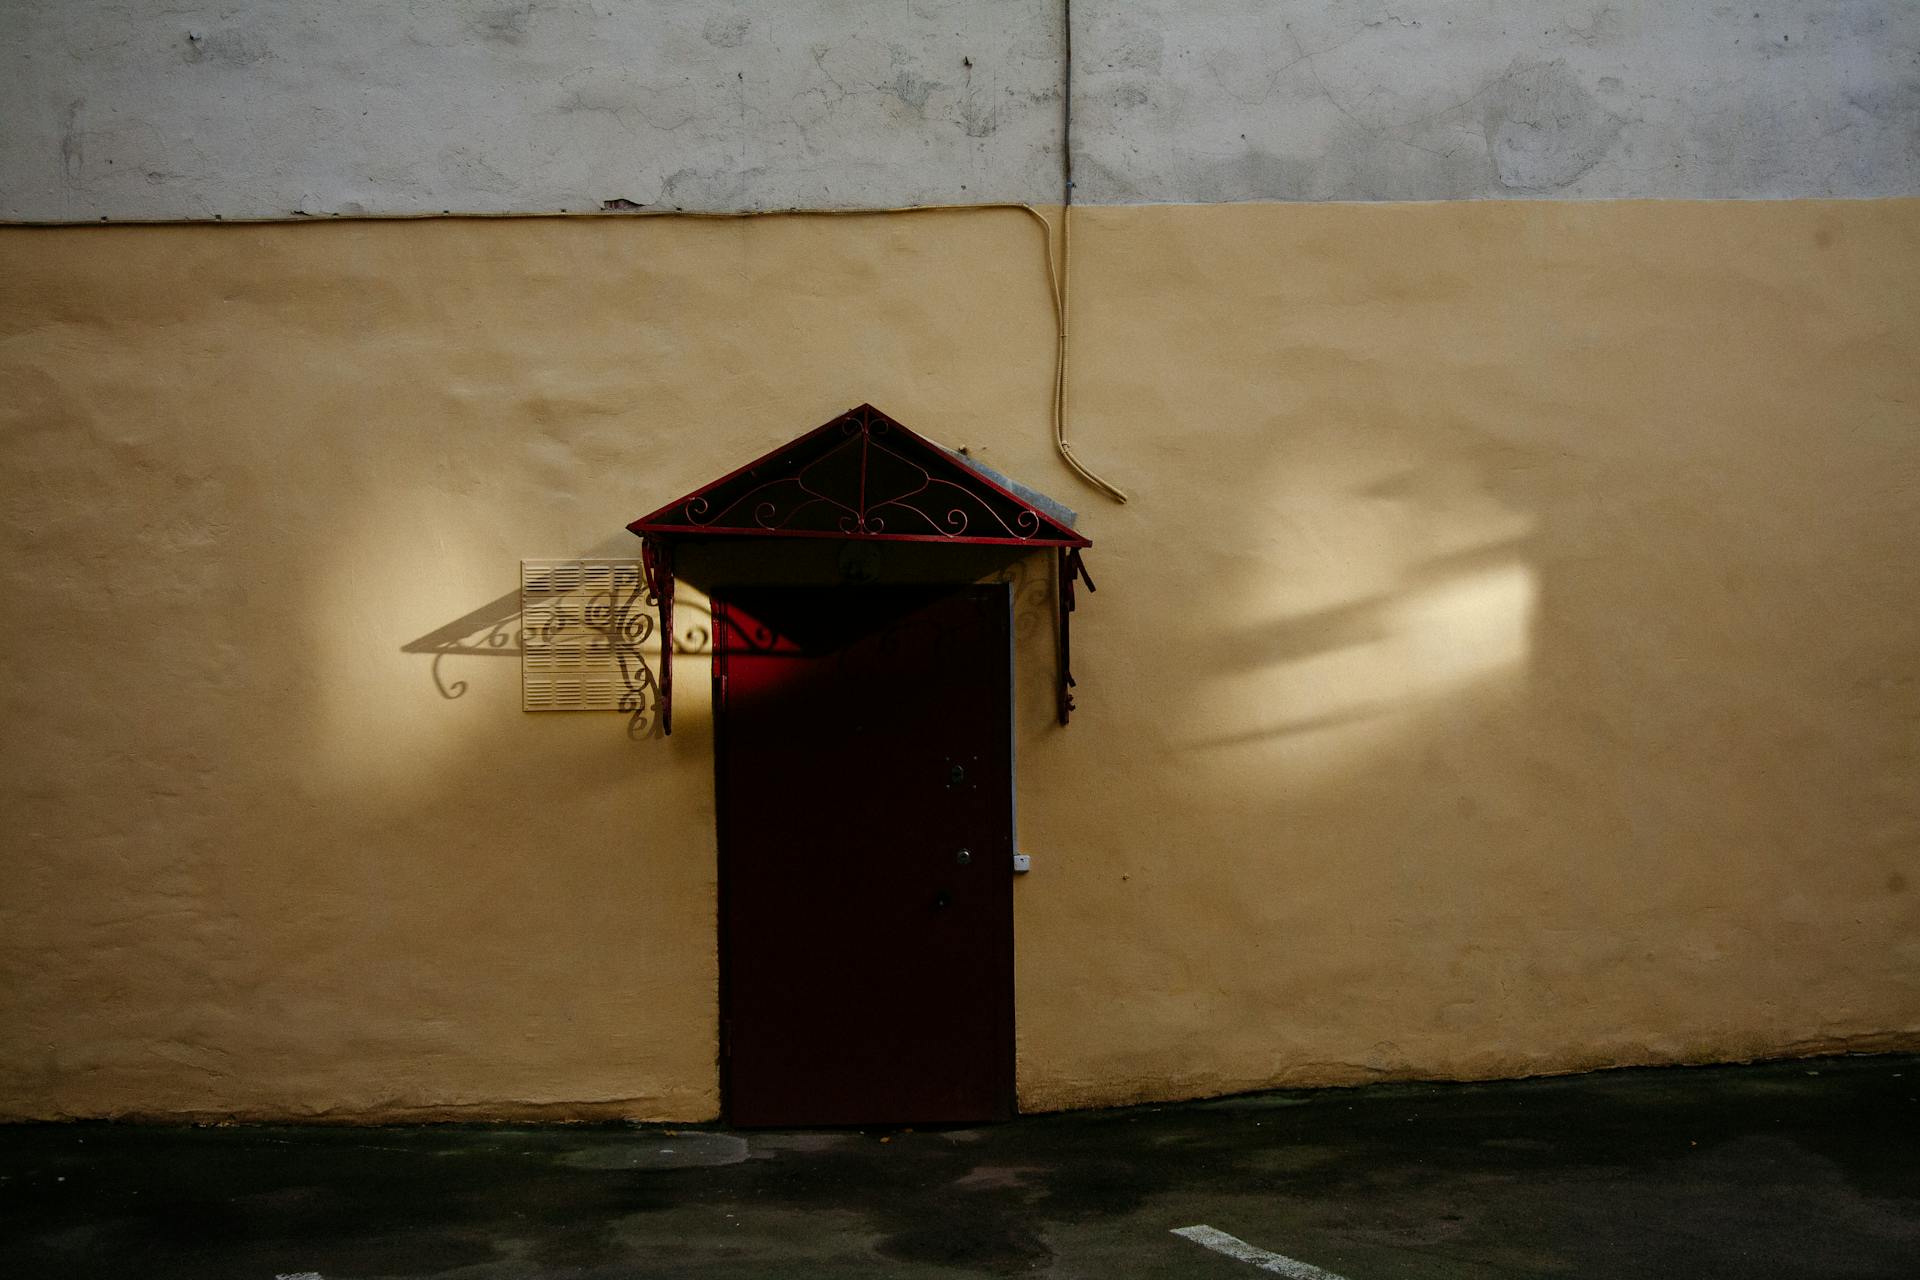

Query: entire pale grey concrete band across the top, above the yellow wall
left=0, top=0, right=1920, bottom=221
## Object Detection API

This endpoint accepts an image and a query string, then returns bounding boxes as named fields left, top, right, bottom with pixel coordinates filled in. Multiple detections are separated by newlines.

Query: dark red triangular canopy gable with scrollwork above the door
left=626, top=405, right=1092, bottom=547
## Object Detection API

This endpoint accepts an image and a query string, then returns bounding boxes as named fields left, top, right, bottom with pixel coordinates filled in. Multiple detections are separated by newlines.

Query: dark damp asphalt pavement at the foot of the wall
left=0, top=1055, right=1920, bottom=1280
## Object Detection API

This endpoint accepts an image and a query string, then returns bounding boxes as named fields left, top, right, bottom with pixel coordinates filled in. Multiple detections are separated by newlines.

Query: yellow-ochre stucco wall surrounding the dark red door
left=0, top=201, right=1920, bottom=1119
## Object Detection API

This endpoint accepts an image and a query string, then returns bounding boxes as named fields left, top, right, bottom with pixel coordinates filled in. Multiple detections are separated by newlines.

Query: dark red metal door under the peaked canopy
left=714, top=585, right=1014, bottom=1125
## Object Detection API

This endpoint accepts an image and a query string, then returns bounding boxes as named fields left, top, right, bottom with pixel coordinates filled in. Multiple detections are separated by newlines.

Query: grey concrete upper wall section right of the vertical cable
left=1073, top=0, right=1920, bottom=203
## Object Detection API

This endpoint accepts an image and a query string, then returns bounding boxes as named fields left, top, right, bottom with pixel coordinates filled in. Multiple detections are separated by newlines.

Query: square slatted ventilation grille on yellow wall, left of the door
left=520, top=560, right=653, bottom=712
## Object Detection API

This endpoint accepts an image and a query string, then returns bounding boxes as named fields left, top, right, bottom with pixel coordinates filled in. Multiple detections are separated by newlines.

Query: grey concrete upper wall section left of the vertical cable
left=0, top=0, right=1062, bottom=221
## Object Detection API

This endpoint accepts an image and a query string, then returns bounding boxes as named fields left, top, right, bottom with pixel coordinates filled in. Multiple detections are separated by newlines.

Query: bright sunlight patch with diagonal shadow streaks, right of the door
left=1185, top=433, right=1542, bottom=789
